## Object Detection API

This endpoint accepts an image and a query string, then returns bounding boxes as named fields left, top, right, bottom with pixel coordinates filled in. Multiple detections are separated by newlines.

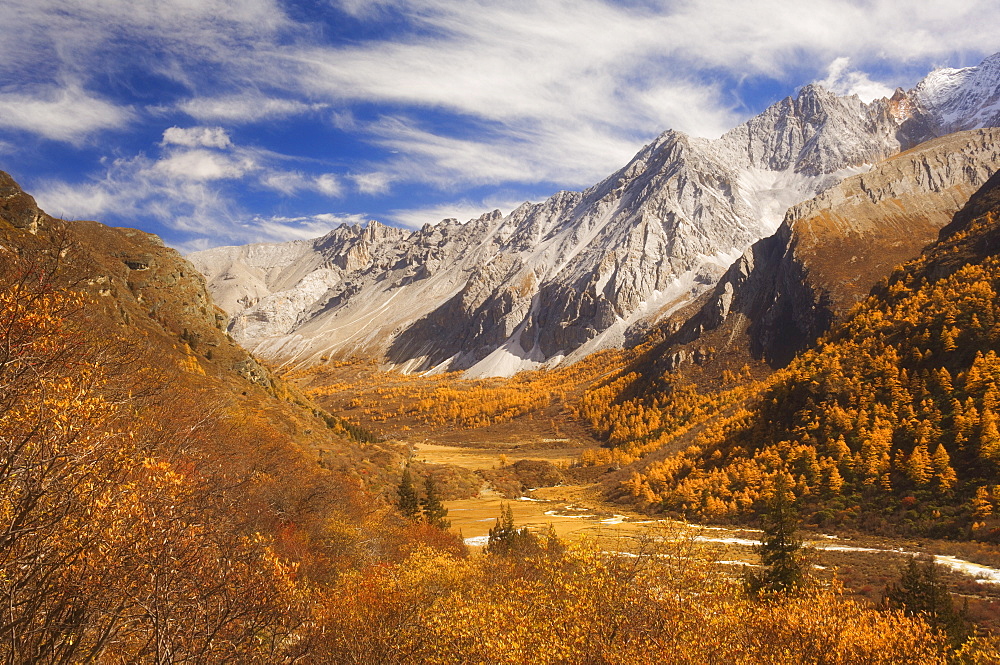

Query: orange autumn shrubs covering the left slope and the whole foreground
left=0, top=249, right=991, bottom=663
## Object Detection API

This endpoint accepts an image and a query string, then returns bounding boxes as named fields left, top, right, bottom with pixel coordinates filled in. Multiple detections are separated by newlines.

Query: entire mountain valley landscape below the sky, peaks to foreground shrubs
left=9, top=54, right=1000, bottom=664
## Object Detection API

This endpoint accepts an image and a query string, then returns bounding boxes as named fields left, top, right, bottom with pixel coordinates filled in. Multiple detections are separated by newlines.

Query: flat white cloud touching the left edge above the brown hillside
left=0, top=85, right=134, bottom=143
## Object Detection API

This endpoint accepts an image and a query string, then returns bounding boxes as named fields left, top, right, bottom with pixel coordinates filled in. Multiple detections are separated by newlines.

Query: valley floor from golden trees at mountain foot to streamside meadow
left=297, top=363, right=1000, bottom=631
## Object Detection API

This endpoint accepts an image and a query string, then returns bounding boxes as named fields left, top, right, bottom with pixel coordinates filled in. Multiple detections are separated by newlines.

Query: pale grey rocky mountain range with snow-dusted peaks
left=188, top=54, right=1000, bottom=376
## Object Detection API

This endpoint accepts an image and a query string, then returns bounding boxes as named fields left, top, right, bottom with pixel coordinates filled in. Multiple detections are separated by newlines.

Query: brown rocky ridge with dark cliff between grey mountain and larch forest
left=663, top=129, right=1000, bottom=366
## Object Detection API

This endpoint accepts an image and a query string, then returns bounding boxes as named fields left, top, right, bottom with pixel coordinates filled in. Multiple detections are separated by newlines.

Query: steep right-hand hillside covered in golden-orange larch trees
left=595, top=170, right=1000, bottom=540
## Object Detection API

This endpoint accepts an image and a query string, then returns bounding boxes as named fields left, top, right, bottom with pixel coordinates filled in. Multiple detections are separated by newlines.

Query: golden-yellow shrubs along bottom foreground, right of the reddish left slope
left=319, top=534, right=947, bottom=665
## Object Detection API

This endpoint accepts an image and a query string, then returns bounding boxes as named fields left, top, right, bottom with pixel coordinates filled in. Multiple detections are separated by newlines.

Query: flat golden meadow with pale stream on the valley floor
left=413, top=437, right=1000, bottom=630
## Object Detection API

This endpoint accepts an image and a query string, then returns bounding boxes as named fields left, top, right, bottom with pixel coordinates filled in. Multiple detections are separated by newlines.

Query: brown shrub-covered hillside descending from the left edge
left=0, top=174, right=460, bottom=663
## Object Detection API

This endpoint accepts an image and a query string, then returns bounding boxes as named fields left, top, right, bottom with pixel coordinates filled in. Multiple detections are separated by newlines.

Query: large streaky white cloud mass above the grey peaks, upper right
left=285, top=0, right=1000, bottom=192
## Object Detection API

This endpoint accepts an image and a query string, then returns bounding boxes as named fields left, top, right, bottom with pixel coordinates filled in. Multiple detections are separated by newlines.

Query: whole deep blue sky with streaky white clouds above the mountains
left=0, top=0, right=1000, bottom=251
